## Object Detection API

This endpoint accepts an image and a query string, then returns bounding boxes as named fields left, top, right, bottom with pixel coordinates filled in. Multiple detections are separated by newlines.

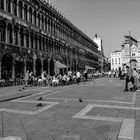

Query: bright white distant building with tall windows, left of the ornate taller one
left=111, top=50, right=122, bottom=70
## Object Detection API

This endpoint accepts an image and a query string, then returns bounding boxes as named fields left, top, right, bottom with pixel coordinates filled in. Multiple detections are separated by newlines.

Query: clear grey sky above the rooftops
left=49, top=0, right=140, bottom=57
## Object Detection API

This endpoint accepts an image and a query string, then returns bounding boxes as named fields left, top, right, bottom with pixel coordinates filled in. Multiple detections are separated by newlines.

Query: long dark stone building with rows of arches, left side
left=0, top=0, right=98, bottom=79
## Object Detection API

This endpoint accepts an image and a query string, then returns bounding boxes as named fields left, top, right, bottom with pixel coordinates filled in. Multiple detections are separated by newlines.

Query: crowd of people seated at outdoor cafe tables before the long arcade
left=24, top=70, right=91, bottom=86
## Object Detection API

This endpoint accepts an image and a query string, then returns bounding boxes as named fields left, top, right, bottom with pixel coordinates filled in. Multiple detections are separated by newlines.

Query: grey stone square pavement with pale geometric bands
left=0, top=78, right=140, bottom=140
